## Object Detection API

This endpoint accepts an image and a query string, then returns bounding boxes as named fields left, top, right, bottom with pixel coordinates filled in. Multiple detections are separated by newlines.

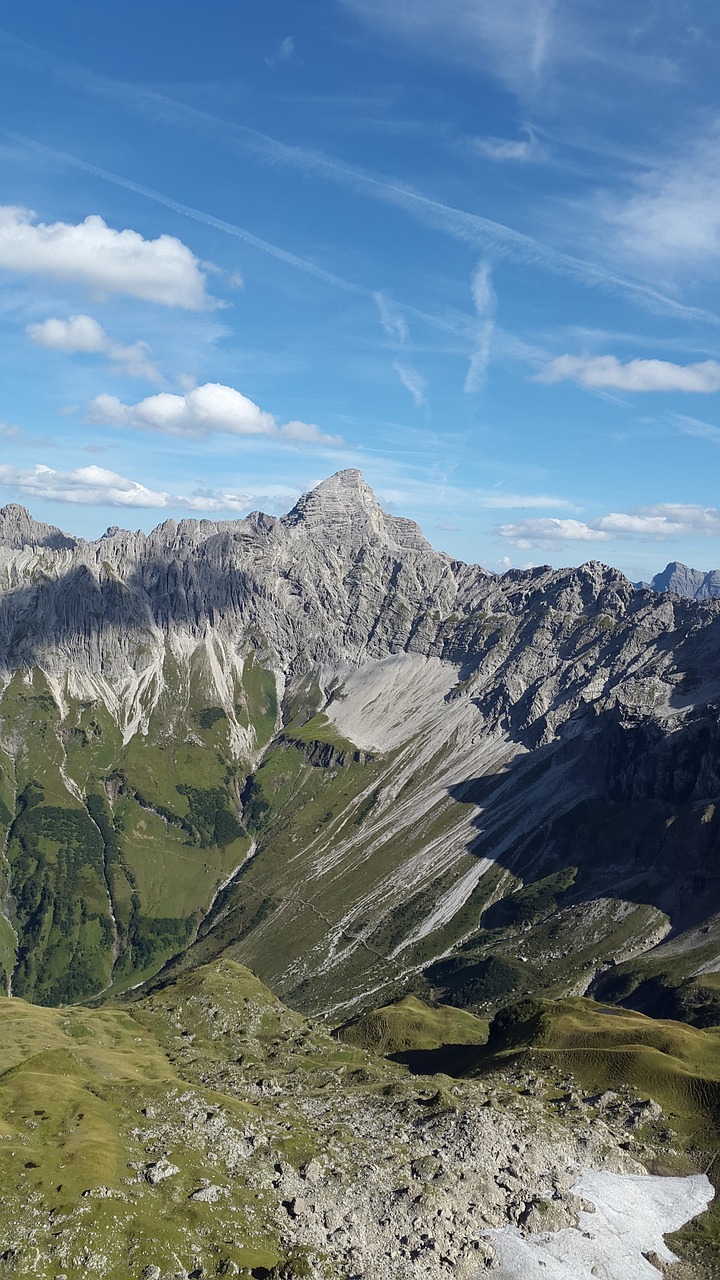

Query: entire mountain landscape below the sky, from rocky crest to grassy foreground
left=0, top=471, right=720, bottom=1280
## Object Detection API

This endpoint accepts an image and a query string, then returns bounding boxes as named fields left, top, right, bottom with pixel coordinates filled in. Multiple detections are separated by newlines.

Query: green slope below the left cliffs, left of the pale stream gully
left=0, top=655, right=277, bottom=1004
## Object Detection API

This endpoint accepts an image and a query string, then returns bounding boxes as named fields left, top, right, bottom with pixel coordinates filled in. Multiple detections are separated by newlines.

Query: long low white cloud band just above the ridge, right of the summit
left=497, top=502, right=720, bottom=548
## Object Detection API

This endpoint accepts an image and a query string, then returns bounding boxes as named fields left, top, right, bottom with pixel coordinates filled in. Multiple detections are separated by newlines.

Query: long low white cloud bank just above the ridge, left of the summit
left=0, top=465, right=300, bottom=515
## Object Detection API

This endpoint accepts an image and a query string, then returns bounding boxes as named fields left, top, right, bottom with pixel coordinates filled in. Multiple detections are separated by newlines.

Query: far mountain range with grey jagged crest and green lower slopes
left=0, top=471, right=720, bottom=1027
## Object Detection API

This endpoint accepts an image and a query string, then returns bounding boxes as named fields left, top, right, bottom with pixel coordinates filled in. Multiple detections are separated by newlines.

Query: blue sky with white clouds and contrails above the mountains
left=0, top=0, right=720, bottom=577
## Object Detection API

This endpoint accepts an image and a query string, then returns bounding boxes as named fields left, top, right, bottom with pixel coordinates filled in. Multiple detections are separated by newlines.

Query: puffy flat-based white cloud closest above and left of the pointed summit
left=88, top=383, right=342, bottom=445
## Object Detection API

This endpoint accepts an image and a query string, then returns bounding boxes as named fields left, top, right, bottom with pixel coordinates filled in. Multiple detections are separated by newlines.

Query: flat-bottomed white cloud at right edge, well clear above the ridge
left=534, top=356, right=720, bottom=394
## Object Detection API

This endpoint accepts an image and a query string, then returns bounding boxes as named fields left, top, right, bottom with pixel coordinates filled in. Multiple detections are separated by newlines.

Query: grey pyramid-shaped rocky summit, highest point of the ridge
left=282, top=467, right=430, bottom=550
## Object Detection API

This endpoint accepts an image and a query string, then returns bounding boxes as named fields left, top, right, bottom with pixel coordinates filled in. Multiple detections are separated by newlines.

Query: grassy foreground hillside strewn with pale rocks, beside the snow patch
left=0, top=960, right=708, bottom=1280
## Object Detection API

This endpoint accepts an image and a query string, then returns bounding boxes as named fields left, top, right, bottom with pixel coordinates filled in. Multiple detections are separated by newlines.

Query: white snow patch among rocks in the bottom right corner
left=483, top=1170, right=715, bottom=1280
